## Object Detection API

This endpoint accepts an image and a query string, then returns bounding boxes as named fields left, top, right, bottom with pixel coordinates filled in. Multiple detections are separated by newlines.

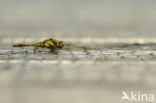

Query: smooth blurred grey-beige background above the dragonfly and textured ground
left=0, top=0, right=156, bottom=37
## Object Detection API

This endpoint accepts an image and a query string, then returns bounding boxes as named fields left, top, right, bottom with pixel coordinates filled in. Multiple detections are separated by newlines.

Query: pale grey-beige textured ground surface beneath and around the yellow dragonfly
left=0, top=38, right=156, bottom=103
